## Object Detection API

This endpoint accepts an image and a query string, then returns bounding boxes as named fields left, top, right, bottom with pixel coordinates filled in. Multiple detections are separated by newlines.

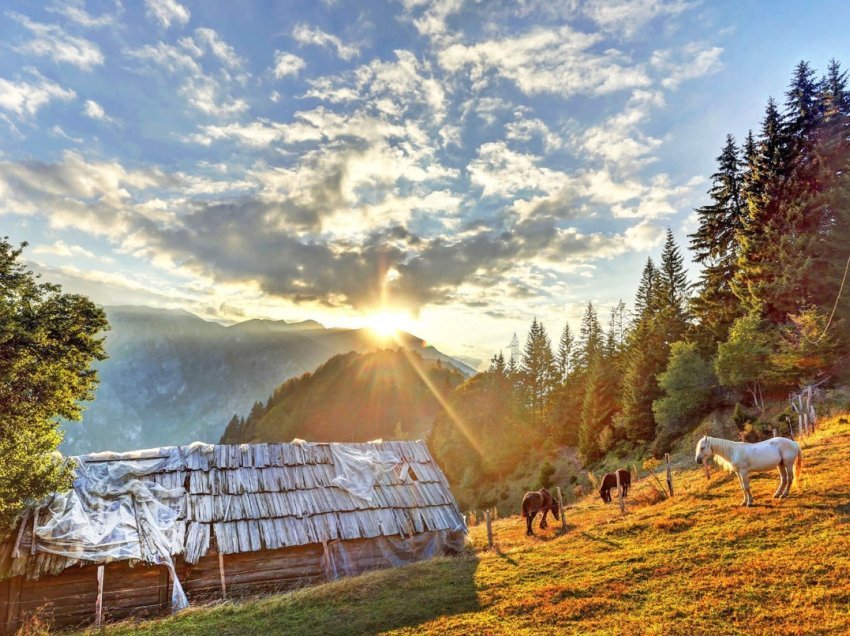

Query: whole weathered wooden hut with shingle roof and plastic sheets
left=0, top=442, right=466, bottom=634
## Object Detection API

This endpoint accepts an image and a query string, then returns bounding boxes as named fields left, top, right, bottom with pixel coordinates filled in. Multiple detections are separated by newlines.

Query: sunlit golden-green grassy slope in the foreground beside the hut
left=79, top=418, right=850, bottom=636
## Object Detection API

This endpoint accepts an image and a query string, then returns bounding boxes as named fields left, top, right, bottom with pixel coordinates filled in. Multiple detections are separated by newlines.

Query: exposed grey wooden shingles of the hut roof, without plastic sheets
left=0, top=441, right=464, bottom=578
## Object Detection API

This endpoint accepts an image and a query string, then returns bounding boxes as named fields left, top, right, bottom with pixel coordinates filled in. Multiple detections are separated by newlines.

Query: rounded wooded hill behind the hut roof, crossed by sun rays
left=221, top=349, right=466, bottom=444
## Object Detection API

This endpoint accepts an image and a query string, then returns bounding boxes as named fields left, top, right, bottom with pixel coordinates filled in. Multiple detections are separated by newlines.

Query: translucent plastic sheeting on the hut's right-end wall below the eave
left=325, top=530, right=466, bottom=580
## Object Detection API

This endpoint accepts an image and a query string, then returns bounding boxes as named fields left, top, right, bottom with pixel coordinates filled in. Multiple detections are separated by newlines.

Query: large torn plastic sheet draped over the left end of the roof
left=35, top=450, right=189, bottom=610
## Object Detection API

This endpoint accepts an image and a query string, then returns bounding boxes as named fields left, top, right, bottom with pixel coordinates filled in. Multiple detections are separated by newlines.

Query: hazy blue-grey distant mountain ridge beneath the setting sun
left=62, top=307, right=473, bottom=454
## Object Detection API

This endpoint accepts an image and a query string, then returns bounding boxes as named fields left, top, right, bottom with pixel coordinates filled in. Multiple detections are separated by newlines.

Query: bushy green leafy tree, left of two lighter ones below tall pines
left=652, top=341, right=717, bottom=456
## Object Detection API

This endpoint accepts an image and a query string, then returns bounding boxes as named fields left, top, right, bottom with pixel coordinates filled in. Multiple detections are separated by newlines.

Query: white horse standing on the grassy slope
left=695, top=435, right=803, bottom=506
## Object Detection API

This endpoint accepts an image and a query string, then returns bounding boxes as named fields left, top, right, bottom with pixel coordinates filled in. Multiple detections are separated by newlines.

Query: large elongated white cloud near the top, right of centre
left=437, top=26, right=650, bottom=97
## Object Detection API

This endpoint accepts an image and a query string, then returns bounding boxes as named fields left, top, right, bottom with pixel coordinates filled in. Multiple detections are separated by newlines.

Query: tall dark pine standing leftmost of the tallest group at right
left=690, top=135, right=752, bottom=352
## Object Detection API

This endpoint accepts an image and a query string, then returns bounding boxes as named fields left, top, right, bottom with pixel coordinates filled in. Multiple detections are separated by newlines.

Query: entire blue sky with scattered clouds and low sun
left=0, top=0, right=850, bottom=364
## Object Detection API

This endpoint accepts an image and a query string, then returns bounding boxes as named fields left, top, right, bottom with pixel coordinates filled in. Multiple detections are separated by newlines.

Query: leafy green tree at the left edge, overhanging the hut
left=0, top=238, right=108, bottom=535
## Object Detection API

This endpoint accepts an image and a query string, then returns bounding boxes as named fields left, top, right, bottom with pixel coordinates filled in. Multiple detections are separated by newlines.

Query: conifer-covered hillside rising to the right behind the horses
left=430, top=61, right=850, bottom=505
